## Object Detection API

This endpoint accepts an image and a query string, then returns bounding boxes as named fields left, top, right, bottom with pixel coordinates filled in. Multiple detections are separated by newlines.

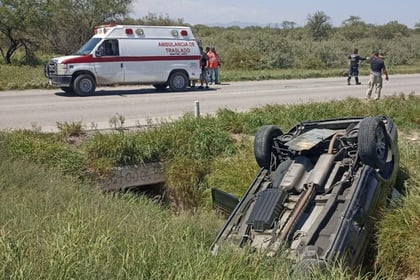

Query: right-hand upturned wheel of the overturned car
left=357, top=117, right=389, bottom=169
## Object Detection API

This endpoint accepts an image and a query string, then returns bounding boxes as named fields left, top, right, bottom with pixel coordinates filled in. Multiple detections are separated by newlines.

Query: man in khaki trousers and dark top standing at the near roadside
left=366, top=51, right=389, bottom=100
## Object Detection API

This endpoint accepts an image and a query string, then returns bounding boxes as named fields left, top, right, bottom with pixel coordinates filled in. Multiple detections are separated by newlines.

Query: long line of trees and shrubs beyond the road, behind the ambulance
left=0, top=0, right=420, bottom=70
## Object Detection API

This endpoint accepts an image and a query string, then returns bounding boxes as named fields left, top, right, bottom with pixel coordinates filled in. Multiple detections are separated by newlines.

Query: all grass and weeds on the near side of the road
left=0, top=94, right=420, bottom=279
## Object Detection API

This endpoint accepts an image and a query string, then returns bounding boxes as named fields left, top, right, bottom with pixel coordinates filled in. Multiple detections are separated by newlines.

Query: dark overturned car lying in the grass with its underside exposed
left=211, top=116, right=399, bottom=268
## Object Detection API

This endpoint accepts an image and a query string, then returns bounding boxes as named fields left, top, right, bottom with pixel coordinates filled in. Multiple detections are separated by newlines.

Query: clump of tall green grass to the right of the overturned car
left=378, top=141, right=420, bottom=275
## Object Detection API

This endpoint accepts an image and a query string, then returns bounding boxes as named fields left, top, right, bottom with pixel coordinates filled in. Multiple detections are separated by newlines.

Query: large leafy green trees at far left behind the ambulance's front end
left=0, top=0, right=133, bottom=64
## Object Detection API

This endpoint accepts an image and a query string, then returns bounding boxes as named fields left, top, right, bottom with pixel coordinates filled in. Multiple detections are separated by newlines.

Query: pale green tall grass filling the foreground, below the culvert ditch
left=0, top=154, right=396, bottom=279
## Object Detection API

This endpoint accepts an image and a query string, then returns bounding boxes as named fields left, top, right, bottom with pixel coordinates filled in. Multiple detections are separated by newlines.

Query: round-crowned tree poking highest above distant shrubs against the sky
left=305, top=11, right=332, bottom=41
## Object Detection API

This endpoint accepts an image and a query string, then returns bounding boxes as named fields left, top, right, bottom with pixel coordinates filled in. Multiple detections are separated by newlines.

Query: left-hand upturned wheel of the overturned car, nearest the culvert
left=254, top=125, right=283, bottom=169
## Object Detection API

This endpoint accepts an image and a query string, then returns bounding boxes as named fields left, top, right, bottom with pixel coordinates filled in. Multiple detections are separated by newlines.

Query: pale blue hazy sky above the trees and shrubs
left=132, top=0, right=420, bottom=28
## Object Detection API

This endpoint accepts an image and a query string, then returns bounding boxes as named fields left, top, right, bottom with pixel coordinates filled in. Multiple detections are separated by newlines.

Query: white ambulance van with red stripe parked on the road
left=45, top=24, right=201, bottom=96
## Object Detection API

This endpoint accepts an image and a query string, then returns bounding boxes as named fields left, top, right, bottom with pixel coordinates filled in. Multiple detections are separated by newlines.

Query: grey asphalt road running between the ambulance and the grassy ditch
left=0, top=74, right=420, bottom=131
